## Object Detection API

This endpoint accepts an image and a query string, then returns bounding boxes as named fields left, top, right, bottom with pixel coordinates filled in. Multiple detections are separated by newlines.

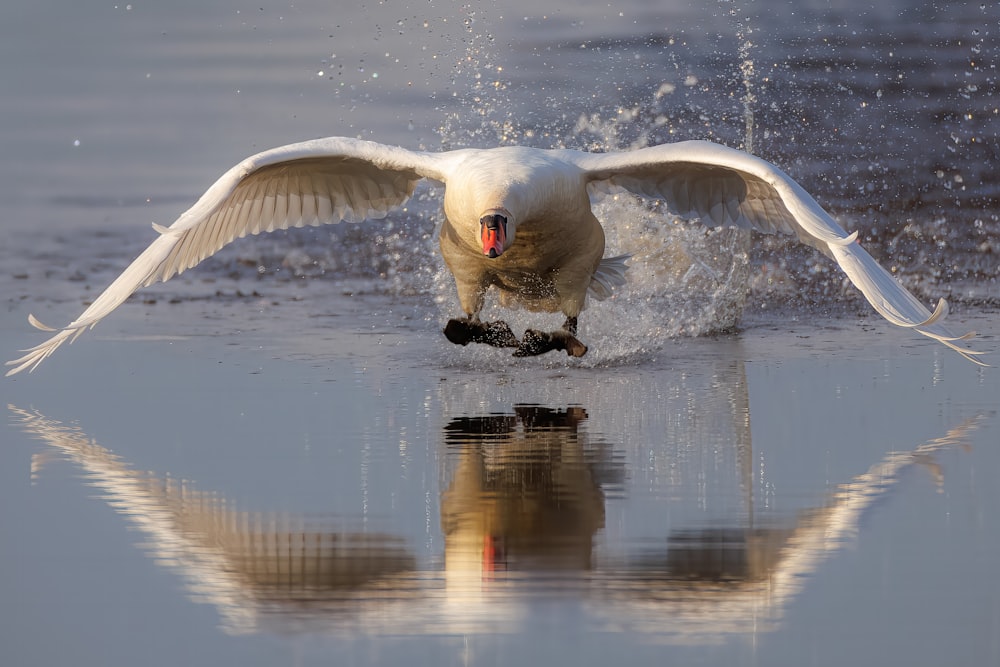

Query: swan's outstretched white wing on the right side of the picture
left=563, top=141, right=985, bottom=365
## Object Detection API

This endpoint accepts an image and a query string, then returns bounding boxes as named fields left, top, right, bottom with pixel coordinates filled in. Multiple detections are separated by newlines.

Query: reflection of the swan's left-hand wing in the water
left=9, top=406, right=418, bottom=633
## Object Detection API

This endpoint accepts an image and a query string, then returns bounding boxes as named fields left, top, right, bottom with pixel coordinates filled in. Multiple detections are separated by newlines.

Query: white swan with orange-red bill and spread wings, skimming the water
left=1, top=137, right=981, bottom=375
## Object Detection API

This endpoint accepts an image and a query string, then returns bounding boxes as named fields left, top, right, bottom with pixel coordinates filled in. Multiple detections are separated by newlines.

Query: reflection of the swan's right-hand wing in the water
left=590, top=416, right=983, bottom=642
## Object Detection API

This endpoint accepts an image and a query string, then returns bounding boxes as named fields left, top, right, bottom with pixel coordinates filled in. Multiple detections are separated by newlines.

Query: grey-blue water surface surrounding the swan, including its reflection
left=0, top=0, right=1000, bottom=666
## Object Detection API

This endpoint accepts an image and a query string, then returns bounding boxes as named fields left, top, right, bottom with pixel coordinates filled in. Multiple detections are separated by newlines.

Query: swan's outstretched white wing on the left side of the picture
left=7, top=137, right=447, bottom=375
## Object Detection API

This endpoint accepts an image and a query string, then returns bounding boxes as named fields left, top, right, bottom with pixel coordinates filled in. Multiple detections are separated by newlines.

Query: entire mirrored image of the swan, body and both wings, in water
left=10, top=406, right=979, bottom=642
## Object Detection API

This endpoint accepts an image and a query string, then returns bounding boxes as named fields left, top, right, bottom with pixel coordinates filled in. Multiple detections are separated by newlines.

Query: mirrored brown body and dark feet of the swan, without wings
left=441, top=405, right=625, bottom=587
